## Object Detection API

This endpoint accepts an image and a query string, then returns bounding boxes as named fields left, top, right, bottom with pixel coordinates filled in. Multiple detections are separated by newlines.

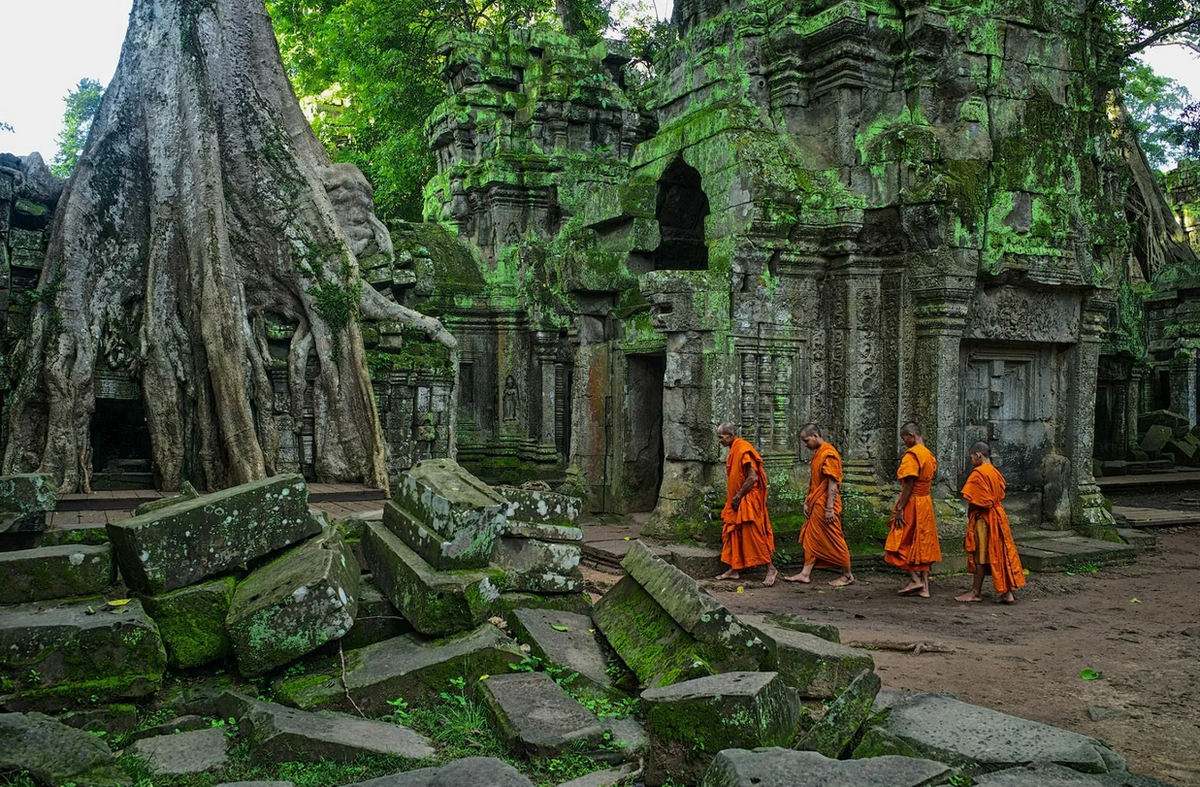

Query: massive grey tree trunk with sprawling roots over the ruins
left=4, top=0, right=454, bottom=492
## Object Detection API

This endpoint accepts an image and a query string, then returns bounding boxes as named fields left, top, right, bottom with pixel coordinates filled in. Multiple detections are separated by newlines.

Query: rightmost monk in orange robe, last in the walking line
left=954, top=443, right=1025, bottom=603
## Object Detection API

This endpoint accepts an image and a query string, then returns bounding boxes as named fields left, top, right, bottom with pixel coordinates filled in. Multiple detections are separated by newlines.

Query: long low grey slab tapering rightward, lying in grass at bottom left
left=231, top=699, right=434, bottom=763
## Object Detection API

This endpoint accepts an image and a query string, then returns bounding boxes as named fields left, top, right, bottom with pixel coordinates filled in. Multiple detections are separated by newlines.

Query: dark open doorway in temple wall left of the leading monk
left=616, top=355, right=667, bottom=512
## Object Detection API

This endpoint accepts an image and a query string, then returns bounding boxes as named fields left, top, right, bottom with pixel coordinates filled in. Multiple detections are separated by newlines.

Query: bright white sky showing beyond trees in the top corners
left=0, top=0, right=1200, bottom=160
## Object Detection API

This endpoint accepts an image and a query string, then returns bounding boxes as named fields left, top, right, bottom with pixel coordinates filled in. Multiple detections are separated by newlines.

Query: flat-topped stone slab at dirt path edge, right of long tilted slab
left=744, top=615, right=875, bottom=699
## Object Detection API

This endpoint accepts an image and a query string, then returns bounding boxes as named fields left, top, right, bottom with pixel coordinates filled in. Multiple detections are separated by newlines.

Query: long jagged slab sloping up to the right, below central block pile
left=275, top=623, right=524, bottom=715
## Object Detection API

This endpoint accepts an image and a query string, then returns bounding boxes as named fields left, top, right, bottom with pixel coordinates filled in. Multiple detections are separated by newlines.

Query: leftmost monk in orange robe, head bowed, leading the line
left=716, top=423, right=779, bottom=587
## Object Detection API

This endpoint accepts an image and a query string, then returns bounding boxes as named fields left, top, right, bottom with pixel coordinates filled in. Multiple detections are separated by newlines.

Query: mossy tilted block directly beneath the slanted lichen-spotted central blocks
left=362, top=522, right=504, bottom=637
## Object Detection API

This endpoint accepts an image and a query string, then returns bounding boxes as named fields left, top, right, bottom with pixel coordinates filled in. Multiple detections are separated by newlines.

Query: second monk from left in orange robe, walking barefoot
left=784, top=423, right=854, bottom=588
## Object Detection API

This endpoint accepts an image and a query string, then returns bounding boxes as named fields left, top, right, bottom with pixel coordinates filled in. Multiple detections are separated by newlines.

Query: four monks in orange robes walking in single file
left=716, top=422, right=1025, bottom=603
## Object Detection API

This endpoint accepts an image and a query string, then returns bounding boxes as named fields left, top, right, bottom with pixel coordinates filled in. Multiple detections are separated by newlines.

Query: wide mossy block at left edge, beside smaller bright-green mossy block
left=0, top=597, right=167, bottom=710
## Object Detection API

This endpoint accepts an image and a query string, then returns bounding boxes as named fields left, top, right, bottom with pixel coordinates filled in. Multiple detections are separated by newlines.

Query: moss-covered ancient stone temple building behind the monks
left=398, top=0, right=1127, bottom=534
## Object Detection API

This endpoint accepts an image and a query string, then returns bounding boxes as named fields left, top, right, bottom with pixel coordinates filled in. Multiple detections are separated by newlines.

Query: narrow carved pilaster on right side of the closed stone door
left=1067, top=294, right=1115, bottom=534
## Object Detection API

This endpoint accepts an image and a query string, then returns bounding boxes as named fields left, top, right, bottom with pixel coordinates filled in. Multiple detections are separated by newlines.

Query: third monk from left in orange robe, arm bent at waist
left=883, top=421, right=942, bottom=599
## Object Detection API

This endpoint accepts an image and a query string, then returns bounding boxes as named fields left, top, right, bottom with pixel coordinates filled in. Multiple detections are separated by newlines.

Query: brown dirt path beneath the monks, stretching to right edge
left=706, top=528, right=1200, bottom=787
